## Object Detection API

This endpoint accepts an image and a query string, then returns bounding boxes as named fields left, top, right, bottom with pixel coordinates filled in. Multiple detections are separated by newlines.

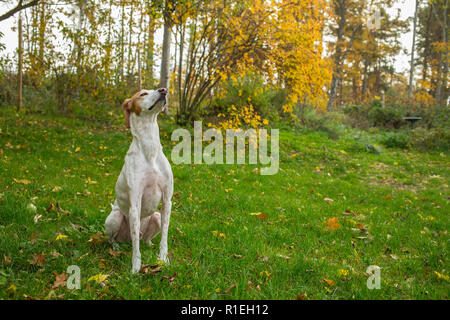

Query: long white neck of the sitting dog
left=130, top=113, right=162, bottom=161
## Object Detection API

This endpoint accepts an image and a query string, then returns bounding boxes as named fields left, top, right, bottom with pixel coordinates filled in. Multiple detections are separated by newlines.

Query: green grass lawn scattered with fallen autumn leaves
left=0, top=112, right=450, bottom=299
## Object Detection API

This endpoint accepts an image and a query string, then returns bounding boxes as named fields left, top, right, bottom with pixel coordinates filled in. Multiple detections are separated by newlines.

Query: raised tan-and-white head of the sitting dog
left=122, top=88, right=169, bottom=128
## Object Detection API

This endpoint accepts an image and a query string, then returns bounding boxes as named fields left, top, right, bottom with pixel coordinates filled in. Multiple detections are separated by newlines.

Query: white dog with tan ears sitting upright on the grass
left=105, top=88, right=173, bottom=273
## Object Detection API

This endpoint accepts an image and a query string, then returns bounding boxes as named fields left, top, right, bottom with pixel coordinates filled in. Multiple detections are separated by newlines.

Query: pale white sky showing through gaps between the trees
left=0, top=0, right=415, bottom=74
